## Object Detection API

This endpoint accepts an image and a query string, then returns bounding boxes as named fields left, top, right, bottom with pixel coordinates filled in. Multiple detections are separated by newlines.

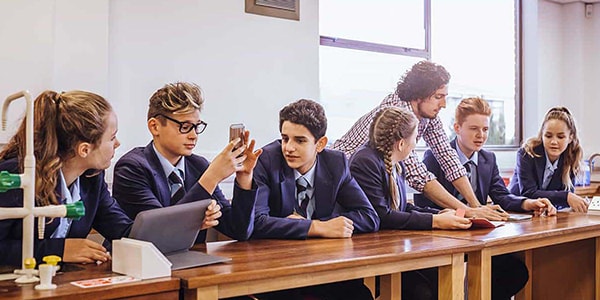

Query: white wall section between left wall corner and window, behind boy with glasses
left=109, top=0, right=319, bottom=157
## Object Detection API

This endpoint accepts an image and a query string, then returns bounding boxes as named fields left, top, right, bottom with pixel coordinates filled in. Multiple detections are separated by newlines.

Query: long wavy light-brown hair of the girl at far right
left=523, top=106, right=583, bottom=190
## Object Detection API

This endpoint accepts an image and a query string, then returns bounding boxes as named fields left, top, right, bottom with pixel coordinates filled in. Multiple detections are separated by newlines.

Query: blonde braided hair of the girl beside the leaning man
left=369, top=107, right=418, bottom=210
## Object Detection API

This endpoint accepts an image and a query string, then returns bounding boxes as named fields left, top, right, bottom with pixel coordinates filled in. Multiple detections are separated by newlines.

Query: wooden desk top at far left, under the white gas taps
left=0, top=263, right=180, bottom=299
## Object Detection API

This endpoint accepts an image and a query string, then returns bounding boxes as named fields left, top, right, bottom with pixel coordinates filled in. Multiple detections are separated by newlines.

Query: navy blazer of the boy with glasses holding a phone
left=113, top=142, right=257, bottom=242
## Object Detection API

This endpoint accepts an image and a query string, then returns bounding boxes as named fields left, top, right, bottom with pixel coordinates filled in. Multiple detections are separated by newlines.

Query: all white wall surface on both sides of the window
left=0, top=0, right=600, bottom=171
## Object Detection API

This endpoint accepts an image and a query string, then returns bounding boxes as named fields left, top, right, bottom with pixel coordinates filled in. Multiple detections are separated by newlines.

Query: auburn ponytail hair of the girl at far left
left=0, top=91, right=112, bottom=206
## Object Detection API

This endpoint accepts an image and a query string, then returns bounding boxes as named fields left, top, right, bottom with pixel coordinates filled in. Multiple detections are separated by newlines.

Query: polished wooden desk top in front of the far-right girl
left=411, top=212, right=600, bottom=252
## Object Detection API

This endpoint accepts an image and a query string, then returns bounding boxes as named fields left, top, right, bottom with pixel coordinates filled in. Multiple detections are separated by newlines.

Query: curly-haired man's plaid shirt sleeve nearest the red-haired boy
left=423, top=117, right=467, bottom=182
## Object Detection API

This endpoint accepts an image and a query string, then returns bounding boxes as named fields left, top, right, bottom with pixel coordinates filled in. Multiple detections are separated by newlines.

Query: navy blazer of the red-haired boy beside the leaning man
left=415, top=138, right=525, bottom=212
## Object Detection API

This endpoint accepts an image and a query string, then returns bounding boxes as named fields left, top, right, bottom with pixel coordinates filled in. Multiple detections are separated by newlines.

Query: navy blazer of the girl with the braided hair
left=350, top=146, right=439, bottom=229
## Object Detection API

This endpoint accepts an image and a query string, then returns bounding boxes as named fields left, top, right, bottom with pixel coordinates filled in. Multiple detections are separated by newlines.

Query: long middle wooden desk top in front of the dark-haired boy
left=173, top=230, right=481, bottom=289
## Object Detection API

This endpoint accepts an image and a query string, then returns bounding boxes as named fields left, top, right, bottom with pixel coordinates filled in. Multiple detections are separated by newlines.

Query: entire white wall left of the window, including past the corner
left=0, top=0, right=319, bottom=158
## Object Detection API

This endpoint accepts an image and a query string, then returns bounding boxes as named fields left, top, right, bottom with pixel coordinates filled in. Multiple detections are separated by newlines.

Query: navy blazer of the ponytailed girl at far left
left=0, top=158, right=132, bottom=266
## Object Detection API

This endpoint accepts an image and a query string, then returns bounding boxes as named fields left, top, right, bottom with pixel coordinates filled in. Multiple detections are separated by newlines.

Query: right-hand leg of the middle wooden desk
left=438, top=253, right=465, bottom=300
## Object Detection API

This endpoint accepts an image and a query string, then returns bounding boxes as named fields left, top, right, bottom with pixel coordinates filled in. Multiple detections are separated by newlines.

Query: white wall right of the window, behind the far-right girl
left=536, top=0, right=600, bottom=157
